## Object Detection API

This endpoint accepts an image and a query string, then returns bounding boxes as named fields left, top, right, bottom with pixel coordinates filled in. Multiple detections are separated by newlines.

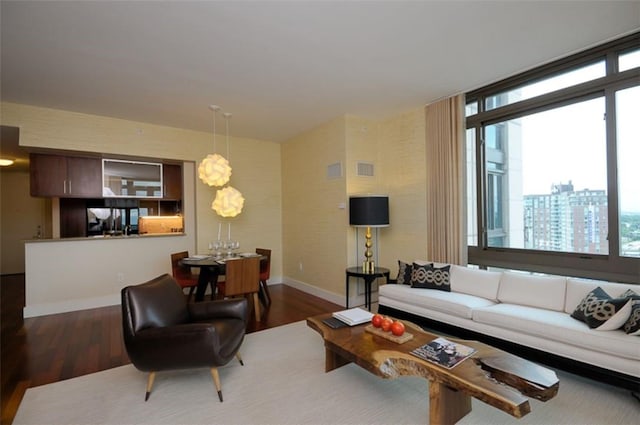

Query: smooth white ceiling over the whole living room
left=0, top=0, right=640, bottom=142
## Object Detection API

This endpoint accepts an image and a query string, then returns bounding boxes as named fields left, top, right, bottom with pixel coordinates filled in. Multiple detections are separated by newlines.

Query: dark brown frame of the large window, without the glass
left=465, top=32, right=640, bottom=283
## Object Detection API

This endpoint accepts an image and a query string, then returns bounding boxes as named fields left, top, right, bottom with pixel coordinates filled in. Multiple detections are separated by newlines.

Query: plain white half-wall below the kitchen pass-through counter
left=24, top=232, right=195, bottom=317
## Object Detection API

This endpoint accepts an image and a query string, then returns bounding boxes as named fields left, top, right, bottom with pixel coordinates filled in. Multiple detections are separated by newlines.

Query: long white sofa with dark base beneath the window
left=379, top=263, right=640, bottom=391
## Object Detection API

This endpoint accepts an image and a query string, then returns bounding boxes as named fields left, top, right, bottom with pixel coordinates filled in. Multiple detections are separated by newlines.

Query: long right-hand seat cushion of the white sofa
left=473, top=304, right=640, bottom=360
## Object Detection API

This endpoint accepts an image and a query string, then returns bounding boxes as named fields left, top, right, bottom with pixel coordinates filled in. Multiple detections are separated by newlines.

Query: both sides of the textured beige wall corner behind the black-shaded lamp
left=282, top=108, right=426, bottom=303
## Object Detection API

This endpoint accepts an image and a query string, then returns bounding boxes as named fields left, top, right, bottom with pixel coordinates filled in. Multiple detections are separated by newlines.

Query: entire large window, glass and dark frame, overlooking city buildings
left=465, top=33, right=640, bottom=282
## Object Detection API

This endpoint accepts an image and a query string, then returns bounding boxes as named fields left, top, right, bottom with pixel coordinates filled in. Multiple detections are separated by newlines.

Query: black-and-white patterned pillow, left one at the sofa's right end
left=571, top=287, right=632, bottom=331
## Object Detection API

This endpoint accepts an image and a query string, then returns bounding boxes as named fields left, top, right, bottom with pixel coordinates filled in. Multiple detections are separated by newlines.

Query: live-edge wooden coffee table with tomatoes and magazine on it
left=307, top=313, right=559, bottom=424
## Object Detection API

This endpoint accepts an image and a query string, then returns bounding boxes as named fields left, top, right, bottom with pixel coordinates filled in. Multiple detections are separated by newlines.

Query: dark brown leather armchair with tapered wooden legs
left=121, top=274, right=249, bottom=401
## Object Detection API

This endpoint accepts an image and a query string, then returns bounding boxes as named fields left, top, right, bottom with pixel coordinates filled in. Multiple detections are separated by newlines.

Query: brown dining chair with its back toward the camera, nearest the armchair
left=218, top=257, right=261, bottom=322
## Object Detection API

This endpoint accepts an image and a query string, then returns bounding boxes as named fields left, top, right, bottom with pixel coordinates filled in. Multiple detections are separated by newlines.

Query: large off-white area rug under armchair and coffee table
left=14, top=322, right=640, bottom=425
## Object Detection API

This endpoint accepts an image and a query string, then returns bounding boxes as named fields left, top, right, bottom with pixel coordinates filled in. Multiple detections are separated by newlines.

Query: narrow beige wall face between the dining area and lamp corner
left=282, top=117, right=348, bottom=296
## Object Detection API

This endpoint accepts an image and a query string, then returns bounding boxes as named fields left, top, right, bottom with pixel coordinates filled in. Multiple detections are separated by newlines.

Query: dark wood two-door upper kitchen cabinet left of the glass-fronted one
left=29, top=154, right=102, bottom=198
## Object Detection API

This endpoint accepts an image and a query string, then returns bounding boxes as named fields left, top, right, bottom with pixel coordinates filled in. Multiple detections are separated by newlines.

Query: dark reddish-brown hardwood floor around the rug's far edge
left=1, top=278, right=343, bottom=425
